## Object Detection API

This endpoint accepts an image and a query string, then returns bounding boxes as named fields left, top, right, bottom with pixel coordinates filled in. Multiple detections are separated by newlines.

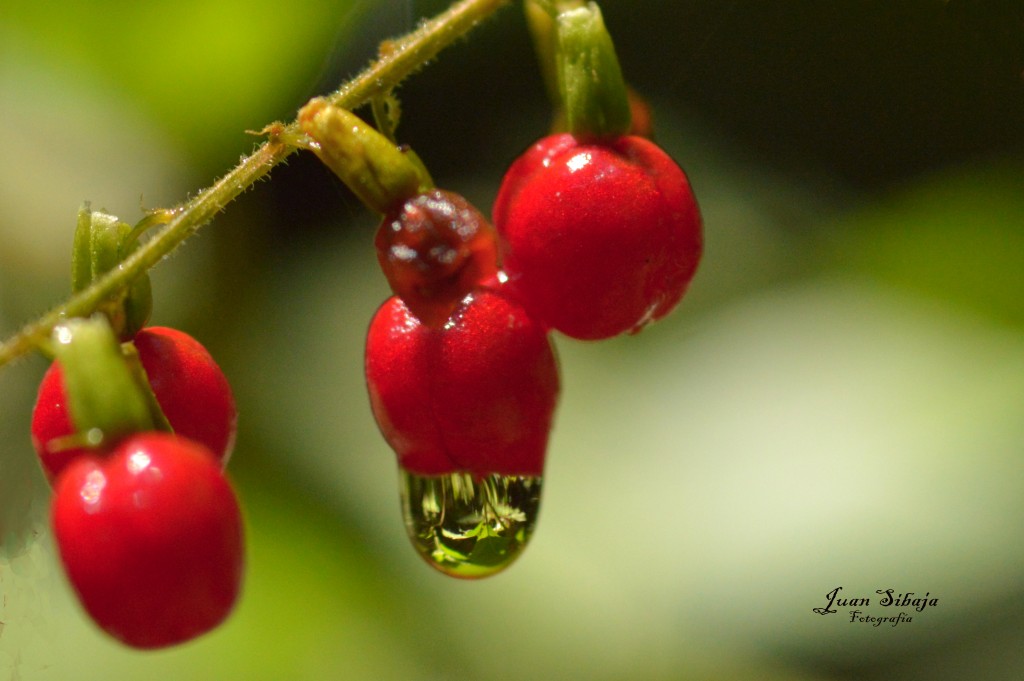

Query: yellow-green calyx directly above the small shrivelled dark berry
left=299, top=97, right=433, bottom=213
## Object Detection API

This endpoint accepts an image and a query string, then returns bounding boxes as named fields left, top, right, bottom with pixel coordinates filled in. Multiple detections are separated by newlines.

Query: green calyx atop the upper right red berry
left=556, top=2, right=632, bottom=138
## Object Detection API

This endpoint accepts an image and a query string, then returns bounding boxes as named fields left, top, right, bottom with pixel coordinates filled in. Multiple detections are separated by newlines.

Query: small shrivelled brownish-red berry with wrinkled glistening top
left=375, top=189, right=498, bottom=328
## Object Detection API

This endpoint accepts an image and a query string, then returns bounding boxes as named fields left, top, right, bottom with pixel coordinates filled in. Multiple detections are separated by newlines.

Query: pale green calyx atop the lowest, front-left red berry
left=53, top=314, right=171, bottom=446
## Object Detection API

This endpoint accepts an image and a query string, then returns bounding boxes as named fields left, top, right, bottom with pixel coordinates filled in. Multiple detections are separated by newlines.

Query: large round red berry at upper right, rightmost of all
left=494, top=134, right=702, bottom=339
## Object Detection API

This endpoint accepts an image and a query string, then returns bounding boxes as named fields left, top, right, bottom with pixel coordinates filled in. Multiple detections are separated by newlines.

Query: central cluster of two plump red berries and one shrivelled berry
left=366, top=133, right=701, bottom=476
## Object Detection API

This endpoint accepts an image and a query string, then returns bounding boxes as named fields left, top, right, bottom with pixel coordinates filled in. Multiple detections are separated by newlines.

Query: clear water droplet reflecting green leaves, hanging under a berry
left=399, top=469, right=541, bottom=579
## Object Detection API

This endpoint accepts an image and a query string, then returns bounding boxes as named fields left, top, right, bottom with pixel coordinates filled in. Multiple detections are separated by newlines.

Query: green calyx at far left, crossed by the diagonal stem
left=71, top=204, right=153, bottom=340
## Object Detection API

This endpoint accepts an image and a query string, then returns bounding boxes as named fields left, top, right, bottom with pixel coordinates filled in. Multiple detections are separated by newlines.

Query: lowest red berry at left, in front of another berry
left=52, top=433, right=245, bottom=648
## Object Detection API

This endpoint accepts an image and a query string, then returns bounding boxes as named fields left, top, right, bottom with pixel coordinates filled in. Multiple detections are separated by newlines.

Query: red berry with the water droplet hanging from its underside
left=366, top=290, right=558, bottom=476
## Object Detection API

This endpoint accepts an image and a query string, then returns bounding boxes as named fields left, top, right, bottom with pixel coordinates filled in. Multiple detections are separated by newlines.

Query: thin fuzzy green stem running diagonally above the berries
left=0, top=0, right=509, bottom=367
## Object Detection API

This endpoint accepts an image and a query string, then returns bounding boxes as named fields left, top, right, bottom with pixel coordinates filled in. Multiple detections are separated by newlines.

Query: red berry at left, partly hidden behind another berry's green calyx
left=32, top=327, right=238, bottom=480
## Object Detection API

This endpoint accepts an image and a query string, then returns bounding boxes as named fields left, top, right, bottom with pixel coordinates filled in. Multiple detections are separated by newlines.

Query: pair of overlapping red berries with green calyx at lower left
left=32, top=204, right=245, bottom=648
